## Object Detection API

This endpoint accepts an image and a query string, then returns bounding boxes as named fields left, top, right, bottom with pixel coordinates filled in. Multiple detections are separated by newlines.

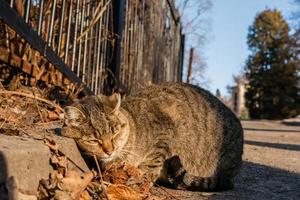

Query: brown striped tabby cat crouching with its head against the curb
left=62, top=83, right=243, bottom=191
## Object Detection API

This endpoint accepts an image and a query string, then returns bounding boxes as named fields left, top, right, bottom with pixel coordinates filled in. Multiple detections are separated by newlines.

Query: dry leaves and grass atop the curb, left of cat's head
left=0, top=80, right=63, bottom=135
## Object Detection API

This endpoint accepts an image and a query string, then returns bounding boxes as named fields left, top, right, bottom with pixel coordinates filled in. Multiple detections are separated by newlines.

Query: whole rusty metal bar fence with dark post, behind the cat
left=0, top=0, right=184, bottom=94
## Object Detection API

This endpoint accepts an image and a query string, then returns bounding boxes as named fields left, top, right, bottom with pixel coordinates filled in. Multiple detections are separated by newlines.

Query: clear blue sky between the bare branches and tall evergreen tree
left=204, top=0, right=293, bottom=95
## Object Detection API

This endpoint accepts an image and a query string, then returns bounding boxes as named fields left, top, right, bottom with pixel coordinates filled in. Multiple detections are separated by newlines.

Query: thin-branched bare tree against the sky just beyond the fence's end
left=175, top=0, right=212, bottom=87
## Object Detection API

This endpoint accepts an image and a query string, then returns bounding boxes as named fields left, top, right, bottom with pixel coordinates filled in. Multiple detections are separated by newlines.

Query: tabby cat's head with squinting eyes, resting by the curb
left=62, top=94, right=128, bottom=161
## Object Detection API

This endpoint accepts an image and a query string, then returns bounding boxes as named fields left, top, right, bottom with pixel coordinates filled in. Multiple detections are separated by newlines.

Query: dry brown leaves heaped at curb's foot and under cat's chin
left=38, top=138, right=162, bottom=200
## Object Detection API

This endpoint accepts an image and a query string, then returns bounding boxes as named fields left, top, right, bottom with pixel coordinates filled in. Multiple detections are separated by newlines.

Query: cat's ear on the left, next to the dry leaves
left=64, top=106, right=86, bottom=126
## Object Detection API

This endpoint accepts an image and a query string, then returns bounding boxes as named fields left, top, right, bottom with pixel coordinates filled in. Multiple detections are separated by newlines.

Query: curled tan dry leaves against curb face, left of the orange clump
left=38, top=138, right=105, bottom=200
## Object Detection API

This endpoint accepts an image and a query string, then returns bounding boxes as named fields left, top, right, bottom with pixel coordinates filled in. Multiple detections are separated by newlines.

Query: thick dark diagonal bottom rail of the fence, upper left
left=0, top=0, right=92, bottom=94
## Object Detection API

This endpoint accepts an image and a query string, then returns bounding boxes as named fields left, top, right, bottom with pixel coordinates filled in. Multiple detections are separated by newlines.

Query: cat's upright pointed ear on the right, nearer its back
left=98, top=93, right=121, bottom=114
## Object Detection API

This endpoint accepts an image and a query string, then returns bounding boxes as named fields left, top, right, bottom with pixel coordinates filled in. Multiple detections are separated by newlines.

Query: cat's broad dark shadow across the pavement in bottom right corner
left=155, top=161, right=300, bottom=200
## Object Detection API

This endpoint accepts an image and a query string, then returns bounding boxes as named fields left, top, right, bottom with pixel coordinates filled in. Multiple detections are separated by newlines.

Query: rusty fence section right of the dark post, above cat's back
left=119, top=0, right=183, bottom=88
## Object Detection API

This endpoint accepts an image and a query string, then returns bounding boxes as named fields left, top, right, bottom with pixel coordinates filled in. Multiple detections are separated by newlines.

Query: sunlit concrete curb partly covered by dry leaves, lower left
left=0, top=135, right=88, bottom=199
